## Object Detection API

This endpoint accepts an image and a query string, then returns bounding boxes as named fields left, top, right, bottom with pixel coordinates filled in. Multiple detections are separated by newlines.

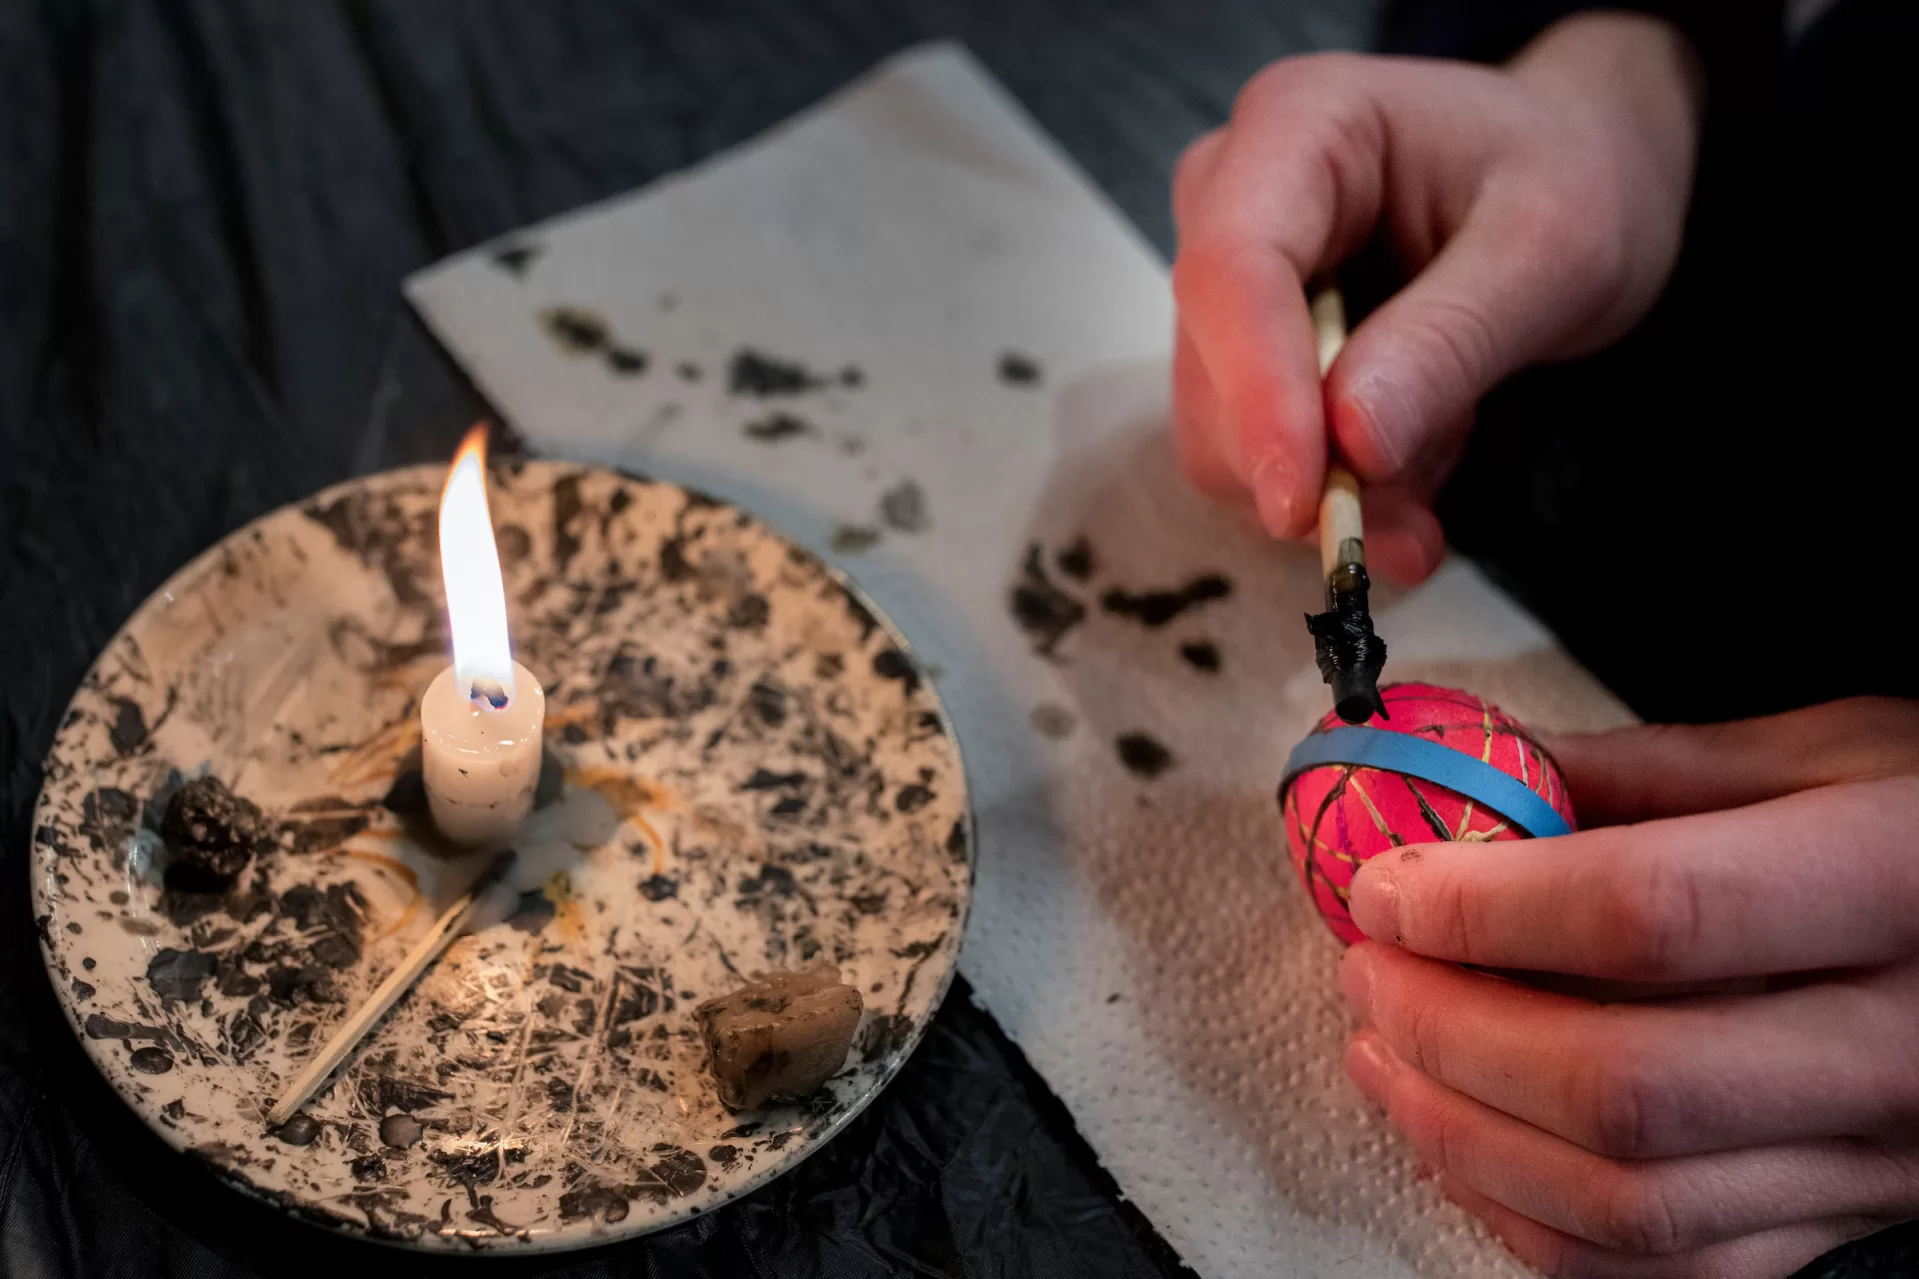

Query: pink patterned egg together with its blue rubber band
left=1280, top=684, right=1574, bottom=943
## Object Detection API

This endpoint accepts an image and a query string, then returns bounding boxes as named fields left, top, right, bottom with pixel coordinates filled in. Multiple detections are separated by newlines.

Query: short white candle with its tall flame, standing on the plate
left=420, top=426, right=547, bottom=847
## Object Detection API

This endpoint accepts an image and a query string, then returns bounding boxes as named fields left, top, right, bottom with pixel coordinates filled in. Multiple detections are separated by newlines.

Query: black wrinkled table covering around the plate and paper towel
left=0, top=0, right=1911, bottom=1279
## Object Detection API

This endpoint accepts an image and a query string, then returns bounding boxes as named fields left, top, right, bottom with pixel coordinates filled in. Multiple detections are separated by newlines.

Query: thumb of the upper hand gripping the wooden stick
left=1326, top=192, right=1616, bottom=490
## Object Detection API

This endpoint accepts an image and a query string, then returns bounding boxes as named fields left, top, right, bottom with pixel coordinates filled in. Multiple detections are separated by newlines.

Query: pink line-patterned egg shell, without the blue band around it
left=1280, top=684, right=1574, bottom=943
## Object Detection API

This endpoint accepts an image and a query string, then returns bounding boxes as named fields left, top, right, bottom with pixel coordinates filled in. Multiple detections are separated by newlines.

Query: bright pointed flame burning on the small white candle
left=439, top=422, right=512, bottom=709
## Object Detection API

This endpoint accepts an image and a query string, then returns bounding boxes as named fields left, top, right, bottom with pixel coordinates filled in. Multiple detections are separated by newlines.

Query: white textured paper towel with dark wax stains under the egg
left=407, top=46, right=1629, bottom=1277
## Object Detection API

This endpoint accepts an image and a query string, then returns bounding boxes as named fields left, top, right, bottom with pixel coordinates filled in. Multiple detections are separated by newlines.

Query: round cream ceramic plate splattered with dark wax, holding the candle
left=33, top=463, right=973, bottom=1250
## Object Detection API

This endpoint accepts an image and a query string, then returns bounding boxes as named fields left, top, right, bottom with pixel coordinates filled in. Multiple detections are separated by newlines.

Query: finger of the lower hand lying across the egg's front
left=1351, top=778, right=1919, bottom=981
